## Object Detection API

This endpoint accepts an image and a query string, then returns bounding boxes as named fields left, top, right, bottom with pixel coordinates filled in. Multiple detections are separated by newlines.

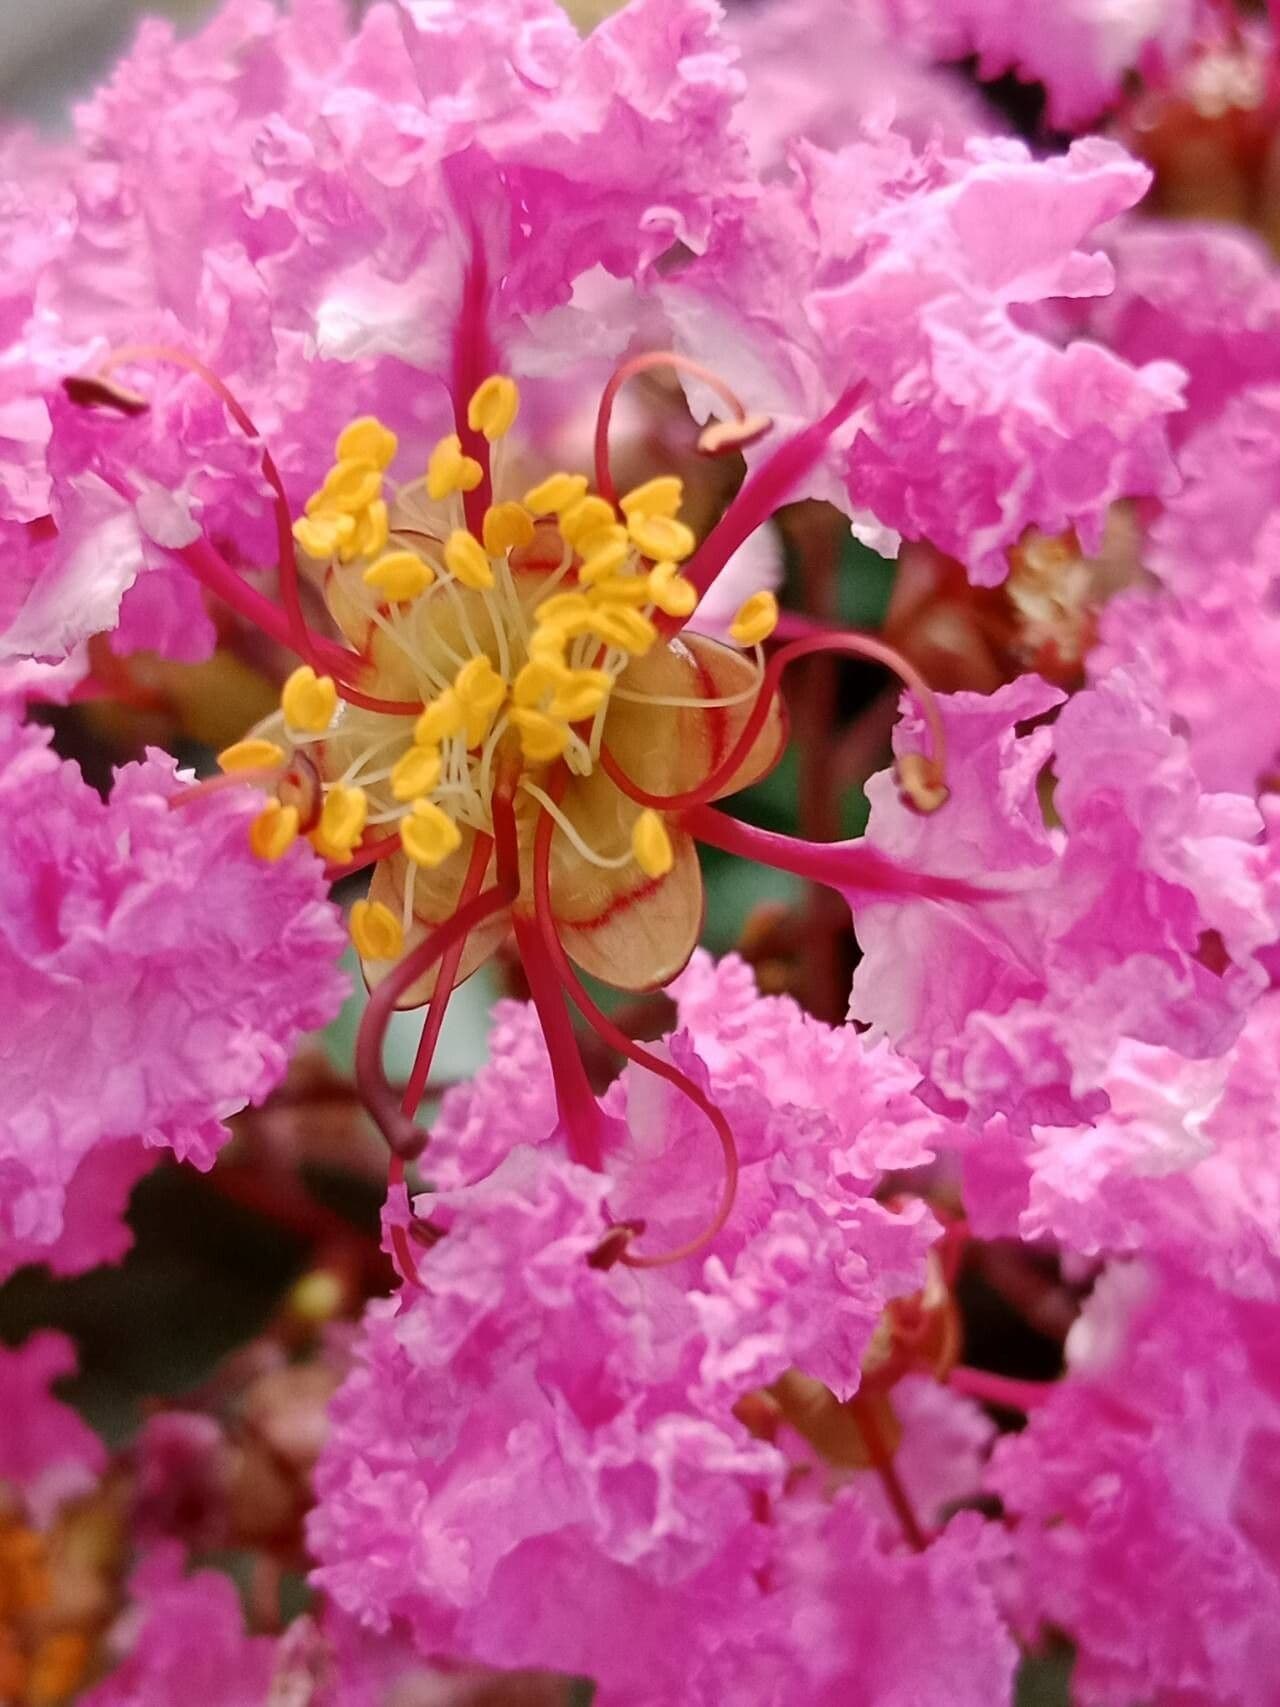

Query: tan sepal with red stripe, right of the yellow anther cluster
left=604, top=633, right=787, bottom=797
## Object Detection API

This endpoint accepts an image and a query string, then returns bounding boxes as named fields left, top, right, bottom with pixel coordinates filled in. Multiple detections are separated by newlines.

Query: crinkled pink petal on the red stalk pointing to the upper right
left=664, top=133, right=1179, bottom=586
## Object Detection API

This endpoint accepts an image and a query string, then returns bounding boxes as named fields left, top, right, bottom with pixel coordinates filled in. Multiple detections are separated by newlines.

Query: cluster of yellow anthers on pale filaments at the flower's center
left=222, top=376, right=777, bottom=958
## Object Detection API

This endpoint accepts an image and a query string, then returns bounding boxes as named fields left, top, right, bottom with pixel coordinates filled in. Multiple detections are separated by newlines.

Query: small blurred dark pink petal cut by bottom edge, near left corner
left=82, top=1547, right=276, bottom=1707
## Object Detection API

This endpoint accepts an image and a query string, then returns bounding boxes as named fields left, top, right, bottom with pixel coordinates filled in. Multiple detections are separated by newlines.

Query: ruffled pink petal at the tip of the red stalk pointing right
left=853, top=671, right=1277, bottom=1125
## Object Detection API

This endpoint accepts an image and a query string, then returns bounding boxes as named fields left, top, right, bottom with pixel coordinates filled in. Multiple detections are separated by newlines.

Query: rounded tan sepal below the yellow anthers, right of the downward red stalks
left=526, top=772, right=703, bottom=990
